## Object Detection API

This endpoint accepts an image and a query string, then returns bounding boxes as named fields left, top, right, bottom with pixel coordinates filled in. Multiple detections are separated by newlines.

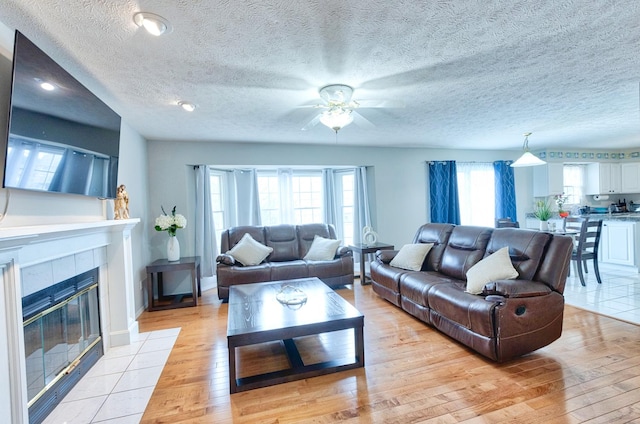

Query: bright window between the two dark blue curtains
left=457, top=162, right=495, bottom=227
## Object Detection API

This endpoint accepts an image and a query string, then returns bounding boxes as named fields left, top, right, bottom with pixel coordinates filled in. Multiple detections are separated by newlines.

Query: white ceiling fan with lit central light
left=302, top=84, right=404, bottom=134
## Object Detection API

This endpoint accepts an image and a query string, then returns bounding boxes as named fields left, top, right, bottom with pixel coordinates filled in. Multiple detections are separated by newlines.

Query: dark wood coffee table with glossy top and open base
left=227, top=278, right=364, bottom=393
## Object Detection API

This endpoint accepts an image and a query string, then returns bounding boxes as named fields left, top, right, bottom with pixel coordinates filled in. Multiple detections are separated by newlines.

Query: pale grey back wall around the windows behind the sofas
left=147, top=141, right=531, bottom=258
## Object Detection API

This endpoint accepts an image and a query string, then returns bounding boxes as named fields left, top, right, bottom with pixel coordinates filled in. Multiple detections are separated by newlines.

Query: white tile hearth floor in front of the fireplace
left=44, top=328, right=180, bottom=424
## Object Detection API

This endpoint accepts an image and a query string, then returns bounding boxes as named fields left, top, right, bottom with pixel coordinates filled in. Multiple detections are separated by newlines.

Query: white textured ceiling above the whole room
left=0, top=0, right=640, bottom=150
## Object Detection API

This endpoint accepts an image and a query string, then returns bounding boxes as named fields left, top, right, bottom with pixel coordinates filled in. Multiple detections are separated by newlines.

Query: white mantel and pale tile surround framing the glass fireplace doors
left=0, top=219, right=140, bottom=423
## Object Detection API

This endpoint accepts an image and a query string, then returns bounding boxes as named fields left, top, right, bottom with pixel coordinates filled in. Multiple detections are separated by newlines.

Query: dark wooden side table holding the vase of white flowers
left=147, top=256, right=202, bottom=311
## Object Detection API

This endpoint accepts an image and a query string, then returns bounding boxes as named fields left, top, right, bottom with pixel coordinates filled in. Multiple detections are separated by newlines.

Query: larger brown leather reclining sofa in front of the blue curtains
left=371, top=223, right=573, bottom=362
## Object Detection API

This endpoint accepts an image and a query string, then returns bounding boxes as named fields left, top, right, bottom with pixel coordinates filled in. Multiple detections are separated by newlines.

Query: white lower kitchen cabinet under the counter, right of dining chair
left=599, top=220, right=639, bottom=266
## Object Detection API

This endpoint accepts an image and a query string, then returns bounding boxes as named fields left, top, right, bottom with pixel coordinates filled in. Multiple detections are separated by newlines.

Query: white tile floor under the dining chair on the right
left=564, top=262, right=640, bottom=325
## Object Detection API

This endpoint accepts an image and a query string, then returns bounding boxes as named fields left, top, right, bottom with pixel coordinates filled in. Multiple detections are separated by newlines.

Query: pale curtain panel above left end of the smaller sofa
left=233, top=169, right=262, bottom=225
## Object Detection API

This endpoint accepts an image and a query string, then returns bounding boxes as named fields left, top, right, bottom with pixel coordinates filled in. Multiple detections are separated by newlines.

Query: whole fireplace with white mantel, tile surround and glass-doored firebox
left=0, top=219, right=140, bottom=424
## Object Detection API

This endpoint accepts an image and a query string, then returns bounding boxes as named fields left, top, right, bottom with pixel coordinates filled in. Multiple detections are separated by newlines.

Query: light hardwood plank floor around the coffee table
left=139, top=283, right=640, bottom=424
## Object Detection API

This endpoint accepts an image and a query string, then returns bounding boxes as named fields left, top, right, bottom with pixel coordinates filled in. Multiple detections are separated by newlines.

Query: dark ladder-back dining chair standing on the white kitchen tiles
left=565, top=218, right=602, bottom=286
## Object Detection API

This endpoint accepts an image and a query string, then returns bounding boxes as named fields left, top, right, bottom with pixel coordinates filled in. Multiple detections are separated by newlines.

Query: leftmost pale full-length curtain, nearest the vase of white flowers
left=193, top=165, right=218, bottom=277
